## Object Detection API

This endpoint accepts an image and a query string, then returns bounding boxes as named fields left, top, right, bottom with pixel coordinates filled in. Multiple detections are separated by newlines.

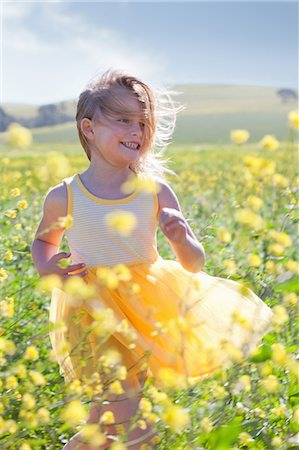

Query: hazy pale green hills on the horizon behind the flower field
left=3, top=84, right=297, bottom=144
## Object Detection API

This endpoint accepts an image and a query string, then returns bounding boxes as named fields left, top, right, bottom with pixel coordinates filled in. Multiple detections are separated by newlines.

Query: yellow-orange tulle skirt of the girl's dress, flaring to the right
left=50, top=257, right=273, bottom=388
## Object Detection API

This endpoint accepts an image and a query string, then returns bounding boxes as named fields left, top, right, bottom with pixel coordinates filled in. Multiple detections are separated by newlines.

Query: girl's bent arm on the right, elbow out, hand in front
left=158, top=182, right=205, bottom=272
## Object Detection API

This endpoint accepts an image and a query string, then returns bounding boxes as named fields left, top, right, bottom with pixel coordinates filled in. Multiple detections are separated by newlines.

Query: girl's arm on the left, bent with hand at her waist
left=31, top=183, right=85, bottom=277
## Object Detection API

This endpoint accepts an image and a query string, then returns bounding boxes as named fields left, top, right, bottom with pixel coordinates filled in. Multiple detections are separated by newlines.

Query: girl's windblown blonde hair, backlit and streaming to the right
left=76, top=69, right=184, bottom=179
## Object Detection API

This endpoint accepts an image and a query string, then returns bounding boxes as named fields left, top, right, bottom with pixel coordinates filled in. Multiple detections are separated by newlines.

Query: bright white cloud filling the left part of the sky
left=2, top=2, right=165, bottom=104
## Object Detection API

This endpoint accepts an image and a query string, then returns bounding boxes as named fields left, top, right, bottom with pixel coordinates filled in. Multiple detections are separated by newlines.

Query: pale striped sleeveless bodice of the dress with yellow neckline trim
left=63, top=174, right=158, bottom=266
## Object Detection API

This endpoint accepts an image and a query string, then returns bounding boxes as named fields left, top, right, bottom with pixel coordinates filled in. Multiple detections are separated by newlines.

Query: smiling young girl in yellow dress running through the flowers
left=32, top=71, right=272, bottom=450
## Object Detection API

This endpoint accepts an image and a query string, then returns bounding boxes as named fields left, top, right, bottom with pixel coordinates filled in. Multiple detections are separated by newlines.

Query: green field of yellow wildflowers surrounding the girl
left=0, top=113, right=299, bottom=450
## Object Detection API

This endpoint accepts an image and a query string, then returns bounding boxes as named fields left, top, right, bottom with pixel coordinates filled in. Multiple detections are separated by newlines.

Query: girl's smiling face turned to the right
left=91, top=88, right=148, bottom=165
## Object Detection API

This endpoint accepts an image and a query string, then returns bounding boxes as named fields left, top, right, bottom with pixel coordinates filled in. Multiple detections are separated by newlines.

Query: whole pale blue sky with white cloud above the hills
left=0, top=1, right=298, bottom=104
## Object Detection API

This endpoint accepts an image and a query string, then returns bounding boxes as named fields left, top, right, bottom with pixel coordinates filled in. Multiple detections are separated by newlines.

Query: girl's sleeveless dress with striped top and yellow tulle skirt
left=49, top=174, right=273, bottom=383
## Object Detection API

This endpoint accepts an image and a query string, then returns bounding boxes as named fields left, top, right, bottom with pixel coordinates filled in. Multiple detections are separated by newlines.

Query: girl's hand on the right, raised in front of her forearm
left=159, top=208, right=188, bottom=244
